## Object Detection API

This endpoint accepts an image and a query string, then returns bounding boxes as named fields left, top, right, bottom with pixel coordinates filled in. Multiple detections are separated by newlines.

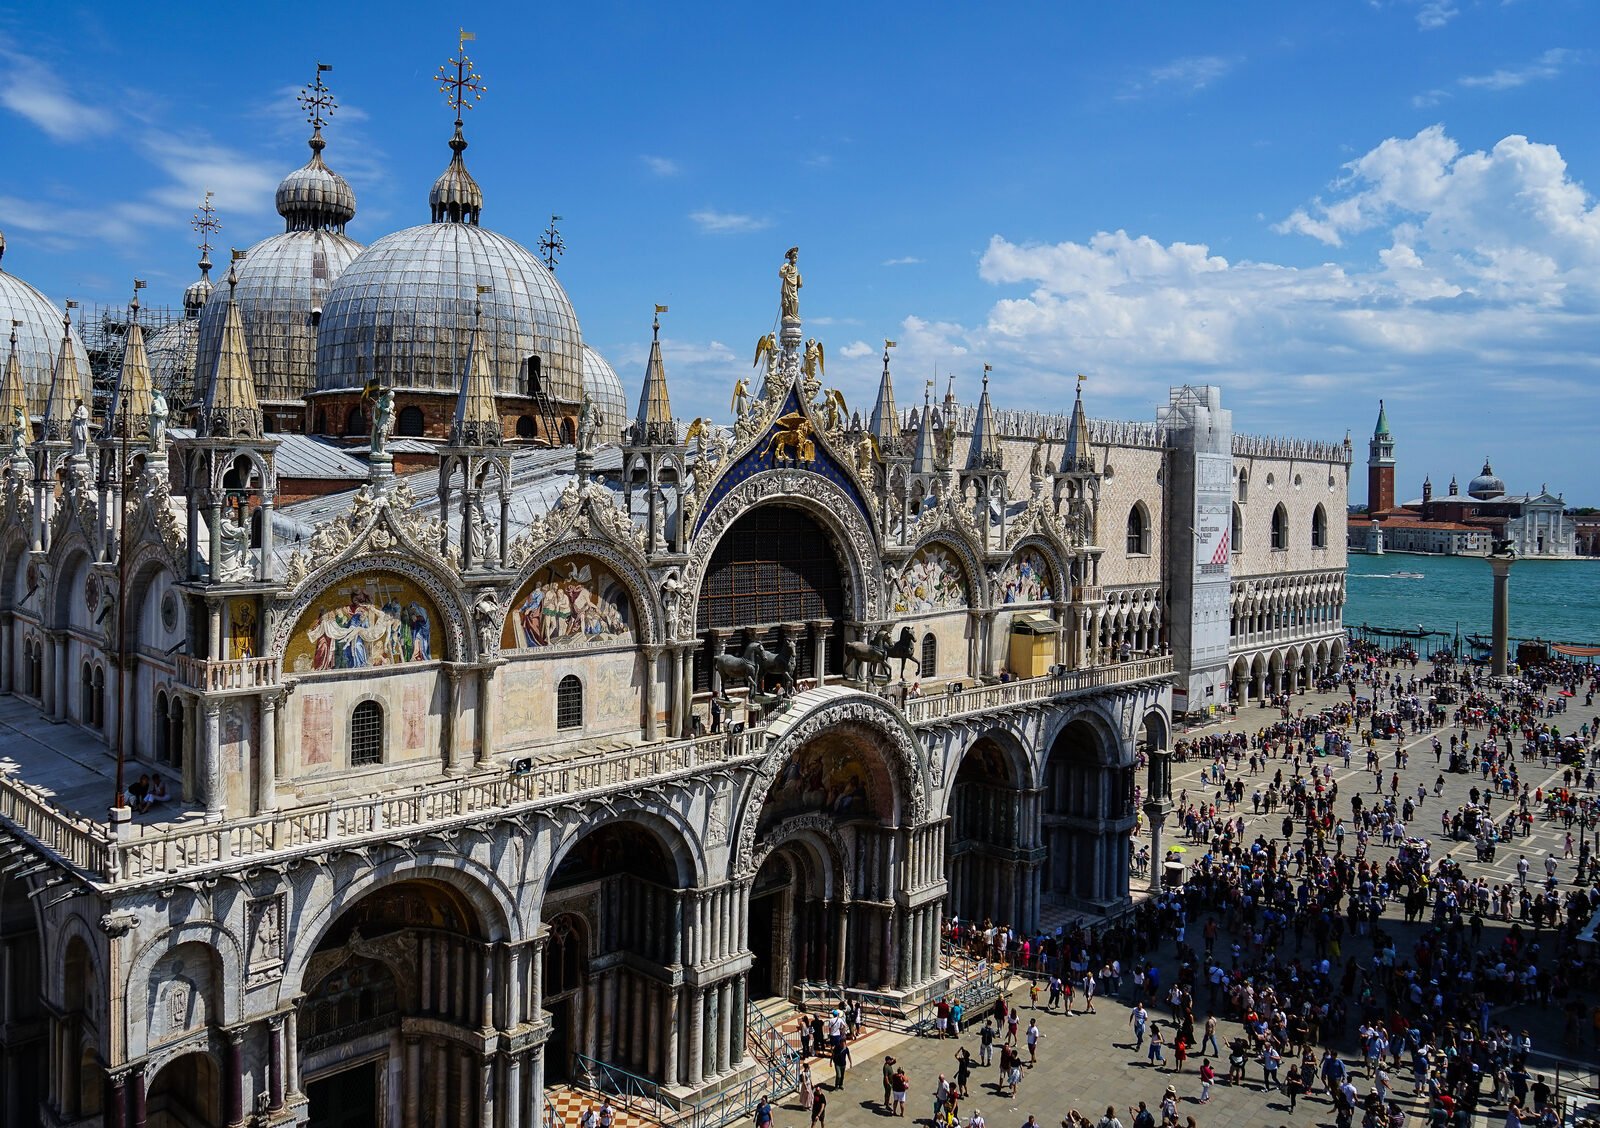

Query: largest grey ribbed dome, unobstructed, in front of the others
left=317, top=221, right=584, bottom=403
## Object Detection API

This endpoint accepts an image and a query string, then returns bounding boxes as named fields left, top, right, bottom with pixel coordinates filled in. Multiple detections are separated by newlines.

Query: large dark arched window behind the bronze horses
left=694, top=504, right=846, bottom=690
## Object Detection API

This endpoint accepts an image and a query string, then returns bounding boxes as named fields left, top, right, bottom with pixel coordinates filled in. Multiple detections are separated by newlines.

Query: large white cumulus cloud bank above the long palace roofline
left=793, top=126, right=1600, bottom=456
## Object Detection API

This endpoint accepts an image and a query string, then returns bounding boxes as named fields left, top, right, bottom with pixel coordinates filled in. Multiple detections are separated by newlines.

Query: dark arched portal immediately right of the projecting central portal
left=946, top=736, right=1038, bottom=930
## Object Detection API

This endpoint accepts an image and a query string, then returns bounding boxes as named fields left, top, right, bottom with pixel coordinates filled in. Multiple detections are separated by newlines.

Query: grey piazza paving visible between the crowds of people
left=774, top=662, right=1597, bottom=1128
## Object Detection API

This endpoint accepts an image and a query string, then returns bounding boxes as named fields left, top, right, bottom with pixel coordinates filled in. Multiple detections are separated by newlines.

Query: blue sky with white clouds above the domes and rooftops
left=0, top=0, right=1600, bottom=502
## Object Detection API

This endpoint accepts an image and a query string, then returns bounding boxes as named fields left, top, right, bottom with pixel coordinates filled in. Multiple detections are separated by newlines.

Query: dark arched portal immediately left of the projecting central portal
left=542, top=819, right=693, bottom=1085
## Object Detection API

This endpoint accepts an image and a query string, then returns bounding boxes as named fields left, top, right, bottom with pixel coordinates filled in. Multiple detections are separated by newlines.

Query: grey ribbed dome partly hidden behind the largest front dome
left=190, top=229, right=362, bottom=402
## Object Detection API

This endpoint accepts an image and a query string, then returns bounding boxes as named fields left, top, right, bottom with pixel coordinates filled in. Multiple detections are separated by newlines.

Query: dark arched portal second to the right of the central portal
left=1040, top=718, right=1134, bottom=907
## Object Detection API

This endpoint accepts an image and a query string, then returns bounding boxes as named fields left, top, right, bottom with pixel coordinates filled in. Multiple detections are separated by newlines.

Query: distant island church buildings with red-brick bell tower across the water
left=1347, top=400, right=1578, bottom=558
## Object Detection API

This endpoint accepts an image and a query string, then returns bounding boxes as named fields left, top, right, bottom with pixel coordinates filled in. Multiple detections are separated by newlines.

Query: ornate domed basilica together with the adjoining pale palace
left=0, top=57, right=1349, bottom=1128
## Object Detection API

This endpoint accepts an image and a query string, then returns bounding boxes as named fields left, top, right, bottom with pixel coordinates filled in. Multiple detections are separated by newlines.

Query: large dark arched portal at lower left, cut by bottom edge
left=298, top=878, right=493, bottom=1128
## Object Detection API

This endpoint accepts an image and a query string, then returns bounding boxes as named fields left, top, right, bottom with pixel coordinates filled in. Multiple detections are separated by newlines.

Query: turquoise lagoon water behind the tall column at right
left=1344, top=552, right=1600, bottom=645
